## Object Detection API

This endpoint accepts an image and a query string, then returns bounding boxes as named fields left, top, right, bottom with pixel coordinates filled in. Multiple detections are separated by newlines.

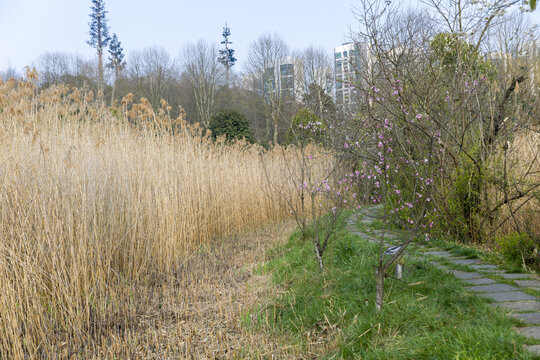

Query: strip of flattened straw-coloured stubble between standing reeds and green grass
left=85, top=223, right=324, bottom=359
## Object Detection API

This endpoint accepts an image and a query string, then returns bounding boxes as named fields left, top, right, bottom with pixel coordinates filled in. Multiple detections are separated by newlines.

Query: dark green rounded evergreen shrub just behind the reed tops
left=208, top=110, right=254, bottom=143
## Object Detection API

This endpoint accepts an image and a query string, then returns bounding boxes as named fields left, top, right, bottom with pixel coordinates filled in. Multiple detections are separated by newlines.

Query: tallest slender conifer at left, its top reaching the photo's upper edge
left=87, top=0, right=111, bottom=90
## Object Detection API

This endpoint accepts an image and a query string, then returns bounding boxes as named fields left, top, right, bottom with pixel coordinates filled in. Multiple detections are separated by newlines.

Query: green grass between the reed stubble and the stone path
left=252, top=218, right=532, bottom=360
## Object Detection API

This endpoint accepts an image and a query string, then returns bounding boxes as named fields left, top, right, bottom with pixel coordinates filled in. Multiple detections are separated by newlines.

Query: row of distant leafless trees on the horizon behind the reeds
left=20, top=43, right=335, bottom=144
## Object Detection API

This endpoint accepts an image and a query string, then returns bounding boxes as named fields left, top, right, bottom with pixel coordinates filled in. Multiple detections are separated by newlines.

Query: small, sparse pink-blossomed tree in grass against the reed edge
left=267, top=108, right=356, bottom=271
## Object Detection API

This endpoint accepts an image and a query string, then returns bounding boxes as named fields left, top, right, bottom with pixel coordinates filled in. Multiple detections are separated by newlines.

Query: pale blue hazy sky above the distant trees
left=0, top=0, right=540, bottom=71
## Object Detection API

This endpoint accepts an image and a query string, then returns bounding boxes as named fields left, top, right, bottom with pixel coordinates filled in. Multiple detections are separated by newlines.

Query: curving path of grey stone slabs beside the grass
left=347, top=207, right=540, bottom=355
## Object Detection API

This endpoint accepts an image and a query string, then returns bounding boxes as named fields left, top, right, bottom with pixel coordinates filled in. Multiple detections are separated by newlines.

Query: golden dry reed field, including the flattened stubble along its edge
left=0, top=72, right=330, bottom=359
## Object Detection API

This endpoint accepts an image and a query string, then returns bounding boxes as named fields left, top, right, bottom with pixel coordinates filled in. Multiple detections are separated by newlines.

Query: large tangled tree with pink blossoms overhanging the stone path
left=335, top=0, right=540, bottom=310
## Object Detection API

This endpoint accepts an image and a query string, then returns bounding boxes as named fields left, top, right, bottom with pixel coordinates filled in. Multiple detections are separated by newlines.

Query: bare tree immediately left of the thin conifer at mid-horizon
left=181, top=40, right=226, bottom=126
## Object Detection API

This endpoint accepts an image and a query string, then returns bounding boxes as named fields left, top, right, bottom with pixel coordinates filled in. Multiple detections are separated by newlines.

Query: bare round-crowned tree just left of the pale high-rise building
left=246, top=34, right=294, bottom=145
